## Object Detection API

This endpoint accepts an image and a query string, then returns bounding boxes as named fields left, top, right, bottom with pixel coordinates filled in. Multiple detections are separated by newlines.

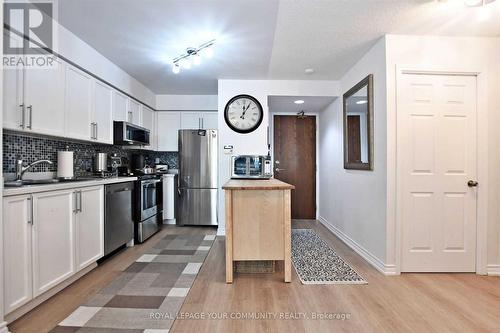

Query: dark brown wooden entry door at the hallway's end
left=274, top=115, right=316, bottom=219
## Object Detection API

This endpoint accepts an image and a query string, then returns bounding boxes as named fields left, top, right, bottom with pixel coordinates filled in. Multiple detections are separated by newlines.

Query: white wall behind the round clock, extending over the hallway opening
left=217, top=80, right=340, bottom=234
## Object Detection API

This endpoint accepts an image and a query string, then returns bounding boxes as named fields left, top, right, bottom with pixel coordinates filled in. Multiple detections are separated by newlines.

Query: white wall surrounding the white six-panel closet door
left=386, top=35, right=500, bottom=270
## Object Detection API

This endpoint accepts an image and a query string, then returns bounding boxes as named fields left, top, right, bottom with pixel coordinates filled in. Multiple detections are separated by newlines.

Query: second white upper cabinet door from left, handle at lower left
left=24, top=51, right=66, bottom=136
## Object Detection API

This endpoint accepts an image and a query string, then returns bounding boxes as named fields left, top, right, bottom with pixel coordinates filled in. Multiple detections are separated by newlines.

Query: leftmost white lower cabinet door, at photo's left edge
left=3, top=195, right=33, bottom=313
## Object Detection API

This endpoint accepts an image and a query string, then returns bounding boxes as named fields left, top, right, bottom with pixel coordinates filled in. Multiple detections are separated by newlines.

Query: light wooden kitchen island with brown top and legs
left=222, top=178, right=295, bottom=283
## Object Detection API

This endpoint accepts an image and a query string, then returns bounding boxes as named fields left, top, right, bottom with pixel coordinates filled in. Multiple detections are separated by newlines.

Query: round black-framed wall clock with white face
left=224, top=95, right=264, bottom=133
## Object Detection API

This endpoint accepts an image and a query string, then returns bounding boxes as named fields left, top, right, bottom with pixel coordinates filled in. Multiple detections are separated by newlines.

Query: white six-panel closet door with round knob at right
left=397, top=74, right=477, bottom=272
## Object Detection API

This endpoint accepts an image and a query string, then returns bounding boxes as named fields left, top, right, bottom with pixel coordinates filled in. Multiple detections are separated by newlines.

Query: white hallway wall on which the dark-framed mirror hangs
left=319, top=38, right=387, bottom=264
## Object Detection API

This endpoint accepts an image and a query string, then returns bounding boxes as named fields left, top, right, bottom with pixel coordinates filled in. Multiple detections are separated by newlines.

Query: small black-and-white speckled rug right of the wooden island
left=292, top=229, right=367, bottom=284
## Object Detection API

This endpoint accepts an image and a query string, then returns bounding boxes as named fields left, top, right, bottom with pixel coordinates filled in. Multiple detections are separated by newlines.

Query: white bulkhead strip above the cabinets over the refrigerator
left=156, top=95, right=217, bottom=111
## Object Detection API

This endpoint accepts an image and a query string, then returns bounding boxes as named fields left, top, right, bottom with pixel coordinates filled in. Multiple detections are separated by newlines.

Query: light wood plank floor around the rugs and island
left=9, top=221, right=500, bottom=333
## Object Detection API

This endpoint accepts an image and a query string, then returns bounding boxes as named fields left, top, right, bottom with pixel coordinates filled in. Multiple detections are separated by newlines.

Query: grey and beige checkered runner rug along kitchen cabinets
left=51, top=234, right=215, bottom=333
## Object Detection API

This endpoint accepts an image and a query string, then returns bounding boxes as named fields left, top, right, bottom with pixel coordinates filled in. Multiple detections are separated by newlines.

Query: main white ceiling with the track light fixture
left=52, top=0, right=500, bottom=94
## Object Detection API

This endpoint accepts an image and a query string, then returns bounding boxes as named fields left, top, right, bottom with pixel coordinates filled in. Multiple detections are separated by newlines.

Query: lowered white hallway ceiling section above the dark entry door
left=267, top=96, right=336, bottom=113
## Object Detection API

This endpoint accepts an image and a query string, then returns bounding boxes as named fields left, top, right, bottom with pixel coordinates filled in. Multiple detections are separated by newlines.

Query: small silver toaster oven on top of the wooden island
left=231, top=155, right=272, bottom=179
